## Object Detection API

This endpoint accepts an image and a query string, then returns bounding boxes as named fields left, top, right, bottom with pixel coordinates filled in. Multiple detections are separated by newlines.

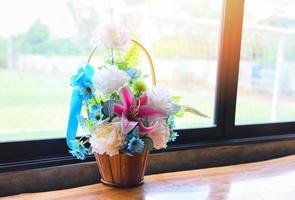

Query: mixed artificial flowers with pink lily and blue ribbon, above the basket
left=67, top=24, right=206, bottom=159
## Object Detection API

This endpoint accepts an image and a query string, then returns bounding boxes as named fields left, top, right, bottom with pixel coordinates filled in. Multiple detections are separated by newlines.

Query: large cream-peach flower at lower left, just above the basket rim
left=89, top=122, right=125, bottom=156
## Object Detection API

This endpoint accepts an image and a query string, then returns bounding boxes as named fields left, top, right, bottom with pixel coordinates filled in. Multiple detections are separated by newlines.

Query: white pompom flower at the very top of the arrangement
left=95, top=22, right=130, bottom=49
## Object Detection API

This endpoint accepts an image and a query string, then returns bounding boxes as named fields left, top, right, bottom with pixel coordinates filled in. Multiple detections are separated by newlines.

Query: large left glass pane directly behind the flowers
left=0, top=0, right=222, bottom=141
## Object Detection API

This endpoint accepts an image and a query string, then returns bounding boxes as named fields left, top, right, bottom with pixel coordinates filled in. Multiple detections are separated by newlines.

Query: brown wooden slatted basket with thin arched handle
left=88, top=39, right=156, bottom=188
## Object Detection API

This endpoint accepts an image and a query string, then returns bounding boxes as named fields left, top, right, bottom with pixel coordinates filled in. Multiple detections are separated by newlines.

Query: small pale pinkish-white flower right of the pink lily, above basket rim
left=148, top=119, right=170, bottom=149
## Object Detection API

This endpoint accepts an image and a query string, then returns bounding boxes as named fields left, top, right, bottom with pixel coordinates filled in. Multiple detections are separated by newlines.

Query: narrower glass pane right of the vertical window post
left=236, top=0, right=295, bottom=124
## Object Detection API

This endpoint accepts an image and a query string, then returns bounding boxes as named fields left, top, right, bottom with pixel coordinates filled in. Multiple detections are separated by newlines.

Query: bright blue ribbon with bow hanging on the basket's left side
left=66, top=64, right=94, bottom=149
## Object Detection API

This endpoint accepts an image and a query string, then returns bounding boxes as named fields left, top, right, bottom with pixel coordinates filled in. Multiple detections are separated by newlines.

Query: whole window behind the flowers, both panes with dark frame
left=0, top=0, right=295, bottom=171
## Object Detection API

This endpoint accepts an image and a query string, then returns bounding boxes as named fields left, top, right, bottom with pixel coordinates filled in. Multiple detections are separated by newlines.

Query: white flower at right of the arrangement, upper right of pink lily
left=147, top=87, right=180, bottom=115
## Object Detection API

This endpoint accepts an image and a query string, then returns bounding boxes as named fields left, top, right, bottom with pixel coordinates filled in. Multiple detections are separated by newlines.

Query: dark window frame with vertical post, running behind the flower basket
left=0, top=0, right=295, bottom=172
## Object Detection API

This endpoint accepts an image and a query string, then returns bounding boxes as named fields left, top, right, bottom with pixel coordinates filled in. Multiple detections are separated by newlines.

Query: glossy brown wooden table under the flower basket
left=4, top=155, right=295, bottom=200
